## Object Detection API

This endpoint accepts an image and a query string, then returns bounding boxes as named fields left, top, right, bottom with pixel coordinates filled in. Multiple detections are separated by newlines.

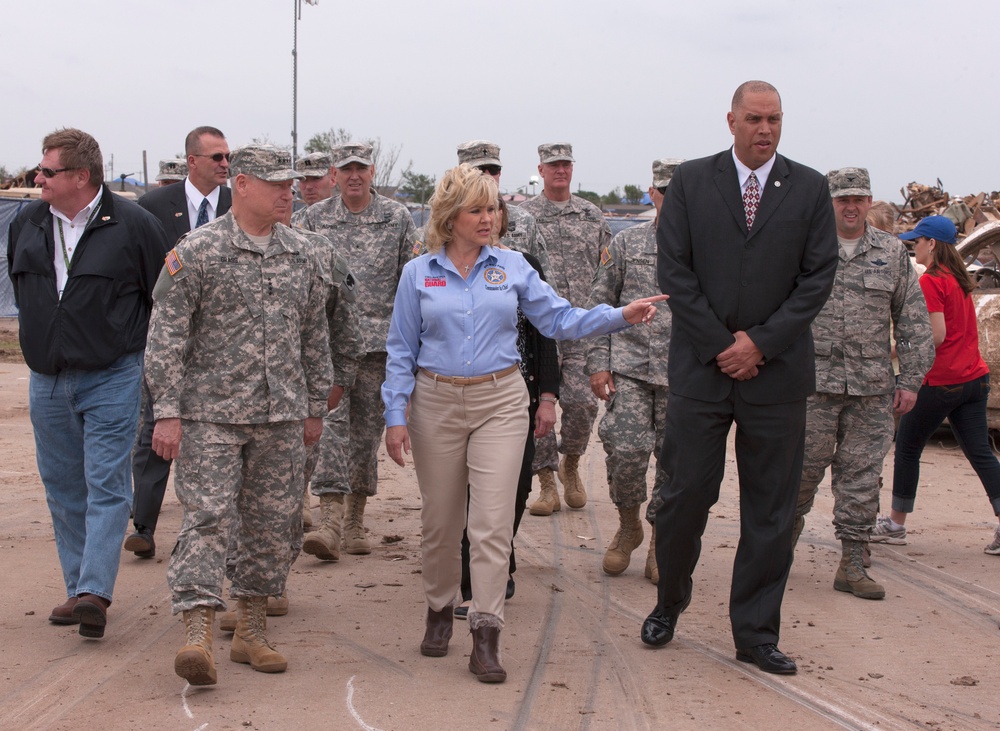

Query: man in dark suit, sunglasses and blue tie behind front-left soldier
left=124, top=127, right=233, bottom=558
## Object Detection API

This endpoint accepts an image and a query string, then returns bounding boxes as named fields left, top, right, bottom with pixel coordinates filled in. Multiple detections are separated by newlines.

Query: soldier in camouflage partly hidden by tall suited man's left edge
left=587, top=159, right=682, bottom=584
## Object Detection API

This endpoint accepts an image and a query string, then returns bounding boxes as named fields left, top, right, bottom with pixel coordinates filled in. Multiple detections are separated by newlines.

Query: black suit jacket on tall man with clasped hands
left=656, top=150, right=838, bottom=404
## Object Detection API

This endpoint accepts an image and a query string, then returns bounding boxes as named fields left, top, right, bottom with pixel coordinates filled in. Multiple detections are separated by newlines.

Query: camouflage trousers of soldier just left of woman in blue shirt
left=311, top=353, right=386, bottom=497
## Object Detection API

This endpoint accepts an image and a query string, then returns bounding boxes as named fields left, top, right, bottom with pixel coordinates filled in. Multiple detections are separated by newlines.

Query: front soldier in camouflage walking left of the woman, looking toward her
left=146, top=145, right=332, bottom=685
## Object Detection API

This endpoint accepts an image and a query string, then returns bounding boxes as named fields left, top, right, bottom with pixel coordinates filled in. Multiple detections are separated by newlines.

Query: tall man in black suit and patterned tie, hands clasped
left=642, top=81, right=837, bottom=674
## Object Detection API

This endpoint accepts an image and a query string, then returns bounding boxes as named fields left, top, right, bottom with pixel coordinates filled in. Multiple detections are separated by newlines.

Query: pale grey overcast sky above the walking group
left=0, top=0, right=1000, bottom=202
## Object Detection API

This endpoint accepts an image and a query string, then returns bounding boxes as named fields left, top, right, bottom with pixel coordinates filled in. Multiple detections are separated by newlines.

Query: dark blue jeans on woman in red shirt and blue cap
left=892, top=373, right=1000, bottom=515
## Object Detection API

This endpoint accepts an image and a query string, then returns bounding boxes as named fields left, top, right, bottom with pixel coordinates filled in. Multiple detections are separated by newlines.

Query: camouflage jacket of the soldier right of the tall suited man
left=812, top=226, right=934, bottom=396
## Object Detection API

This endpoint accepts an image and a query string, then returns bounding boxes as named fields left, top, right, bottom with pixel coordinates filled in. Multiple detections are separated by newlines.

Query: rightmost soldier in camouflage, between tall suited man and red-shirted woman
left=793, top=168, right=934, bottom=599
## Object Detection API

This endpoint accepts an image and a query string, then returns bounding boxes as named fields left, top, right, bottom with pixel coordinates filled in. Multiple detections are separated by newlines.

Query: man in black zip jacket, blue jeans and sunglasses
left=7, top=129, right=167, bottom=638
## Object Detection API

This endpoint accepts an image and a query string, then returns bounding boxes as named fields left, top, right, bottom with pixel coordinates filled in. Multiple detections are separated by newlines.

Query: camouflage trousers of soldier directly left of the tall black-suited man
left=597, top=373, right=667, bottom=508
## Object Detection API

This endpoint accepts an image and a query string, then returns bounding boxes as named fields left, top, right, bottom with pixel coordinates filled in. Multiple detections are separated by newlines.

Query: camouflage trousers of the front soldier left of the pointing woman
left=167, top=420, right=305, bottom=614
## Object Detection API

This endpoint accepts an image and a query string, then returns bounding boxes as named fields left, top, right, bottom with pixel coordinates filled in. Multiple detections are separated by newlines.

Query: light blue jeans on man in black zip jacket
left=29, top=351, right=143, bottom=601
